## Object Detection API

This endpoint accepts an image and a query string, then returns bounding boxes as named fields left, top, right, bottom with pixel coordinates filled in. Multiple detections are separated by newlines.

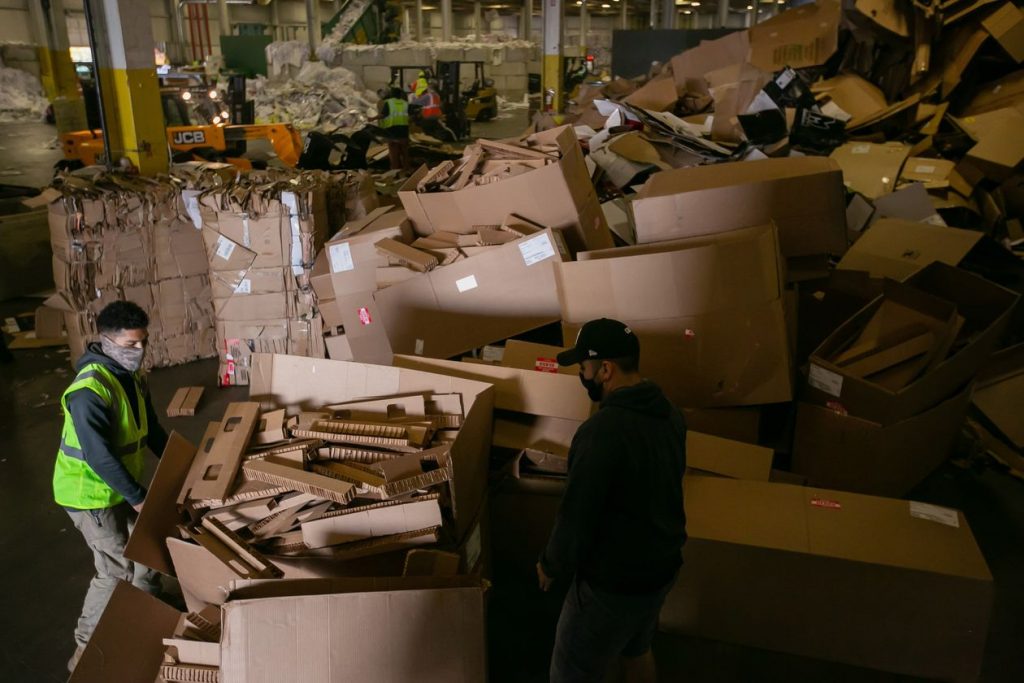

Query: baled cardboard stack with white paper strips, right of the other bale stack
left=187, top=172, right=360, bottom=385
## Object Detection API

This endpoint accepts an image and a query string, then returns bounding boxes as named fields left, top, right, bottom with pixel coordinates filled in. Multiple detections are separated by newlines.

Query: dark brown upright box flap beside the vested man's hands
left=124, top=431, right=196, bottom=577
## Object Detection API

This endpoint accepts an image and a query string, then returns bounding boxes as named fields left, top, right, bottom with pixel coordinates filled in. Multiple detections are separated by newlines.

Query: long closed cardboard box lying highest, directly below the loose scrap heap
left=632, top=157, right=847, bottom=258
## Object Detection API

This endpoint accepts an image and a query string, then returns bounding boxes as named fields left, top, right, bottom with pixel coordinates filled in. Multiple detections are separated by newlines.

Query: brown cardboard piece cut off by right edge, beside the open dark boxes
left=974, top=344, right=1024, bottom=449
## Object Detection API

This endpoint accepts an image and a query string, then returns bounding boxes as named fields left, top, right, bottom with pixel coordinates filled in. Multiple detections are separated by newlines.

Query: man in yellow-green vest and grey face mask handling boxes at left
left=53, top=301, right=167, bottom=671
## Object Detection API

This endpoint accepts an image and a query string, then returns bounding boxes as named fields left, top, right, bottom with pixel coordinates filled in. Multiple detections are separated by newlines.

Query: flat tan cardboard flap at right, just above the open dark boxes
left=837, top=218, right=982, bottom=281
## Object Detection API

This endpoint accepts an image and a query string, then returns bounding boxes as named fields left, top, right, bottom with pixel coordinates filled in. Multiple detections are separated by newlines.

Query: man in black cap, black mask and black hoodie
left=537, top=318, right=686, bottom=683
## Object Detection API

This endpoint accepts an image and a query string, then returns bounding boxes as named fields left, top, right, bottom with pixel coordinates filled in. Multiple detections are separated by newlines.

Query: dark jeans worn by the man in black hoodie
left=550, top=579, right=676, bottom=683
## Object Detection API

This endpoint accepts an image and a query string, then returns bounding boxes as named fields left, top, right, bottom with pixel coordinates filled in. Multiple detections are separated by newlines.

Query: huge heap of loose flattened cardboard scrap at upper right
left=552, top=0, right=1024, bottom=242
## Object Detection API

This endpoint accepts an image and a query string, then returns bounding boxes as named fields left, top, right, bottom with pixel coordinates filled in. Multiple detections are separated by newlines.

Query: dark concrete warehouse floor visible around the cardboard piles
left=0, top=111, right=1024, bottom=683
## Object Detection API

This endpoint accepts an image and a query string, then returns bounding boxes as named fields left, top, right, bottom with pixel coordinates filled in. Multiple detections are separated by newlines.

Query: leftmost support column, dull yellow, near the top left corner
left=29, top=0, right=89, bottom=133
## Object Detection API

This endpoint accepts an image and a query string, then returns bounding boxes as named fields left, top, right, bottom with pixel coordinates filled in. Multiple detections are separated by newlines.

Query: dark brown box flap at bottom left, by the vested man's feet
left=68, top=581, right=181, bottom=683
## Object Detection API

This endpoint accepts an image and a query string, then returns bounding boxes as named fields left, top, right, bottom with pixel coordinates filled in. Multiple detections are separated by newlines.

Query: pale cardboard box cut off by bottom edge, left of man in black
left=221, top=577, right=486, bottom=683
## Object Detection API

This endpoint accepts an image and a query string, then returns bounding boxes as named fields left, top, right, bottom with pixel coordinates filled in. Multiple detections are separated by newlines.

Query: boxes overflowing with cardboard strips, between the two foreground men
left=78, top=354, right=493, bottom=683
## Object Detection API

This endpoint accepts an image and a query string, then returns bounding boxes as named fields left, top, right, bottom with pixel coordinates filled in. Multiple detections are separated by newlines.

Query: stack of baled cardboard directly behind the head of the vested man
left=33, top=173, right=214, bottom=367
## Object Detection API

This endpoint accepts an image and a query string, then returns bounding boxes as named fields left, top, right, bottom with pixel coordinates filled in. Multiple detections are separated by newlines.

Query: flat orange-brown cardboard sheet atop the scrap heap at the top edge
left=748, top=0, right=843, bottom=72
